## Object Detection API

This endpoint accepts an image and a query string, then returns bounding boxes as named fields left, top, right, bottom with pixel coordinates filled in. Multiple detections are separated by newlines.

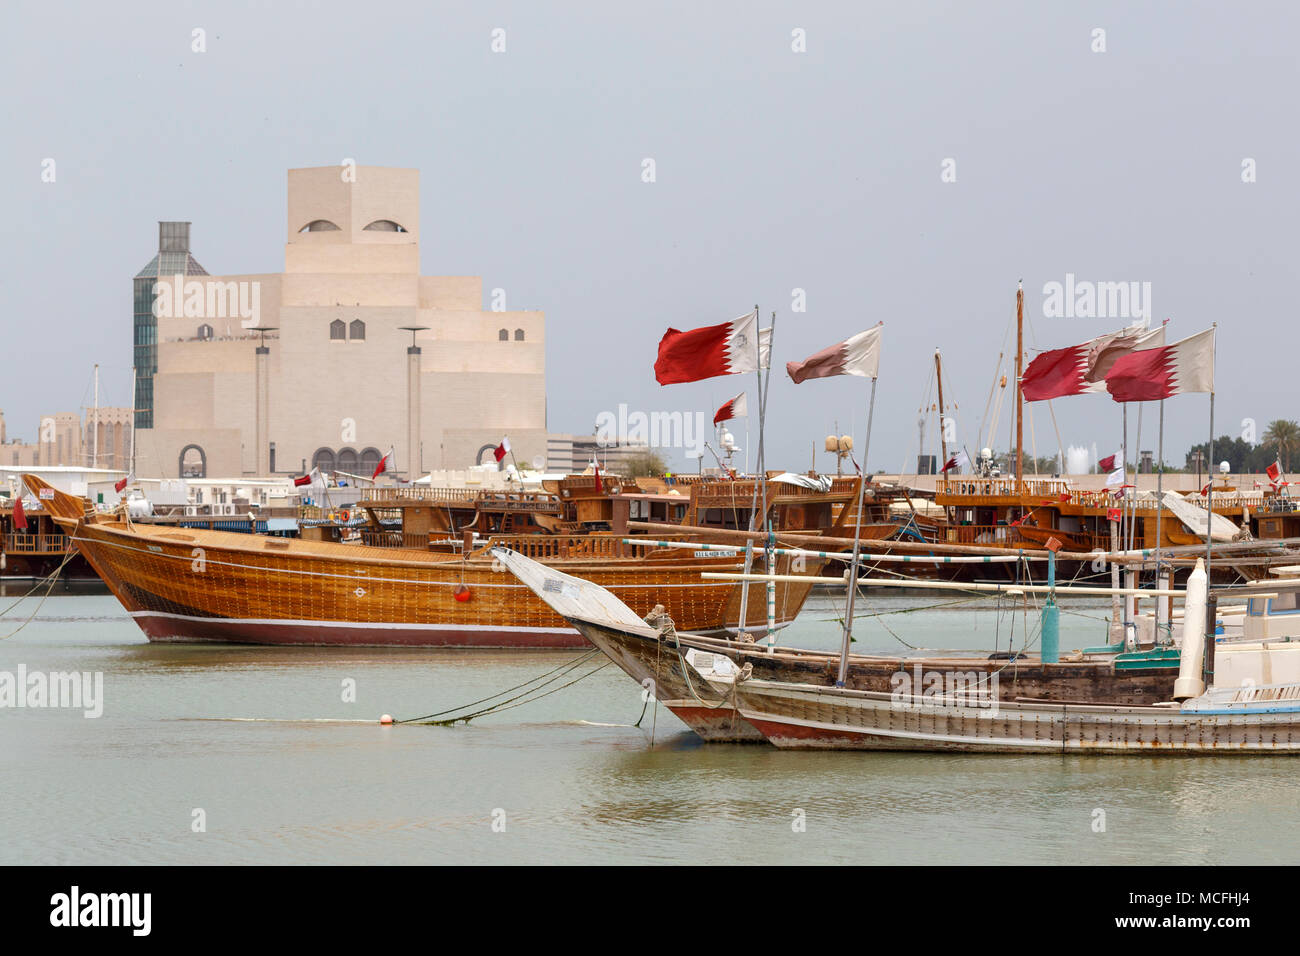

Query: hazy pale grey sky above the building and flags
left=0, top=0, right=1300, bottom=470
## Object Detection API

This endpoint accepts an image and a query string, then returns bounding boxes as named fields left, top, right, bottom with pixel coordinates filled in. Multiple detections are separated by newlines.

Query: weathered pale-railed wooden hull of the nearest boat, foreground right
left=736, top=680, right=1300, bottom=754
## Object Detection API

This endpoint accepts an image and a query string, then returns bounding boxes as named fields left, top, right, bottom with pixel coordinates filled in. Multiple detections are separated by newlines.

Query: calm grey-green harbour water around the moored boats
left=0, top=593, right=1300, bottom=864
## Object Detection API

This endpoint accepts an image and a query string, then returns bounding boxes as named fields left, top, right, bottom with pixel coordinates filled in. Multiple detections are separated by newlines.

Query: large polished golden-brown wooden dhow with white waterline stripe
left=23, top=475, right=855, bottom=648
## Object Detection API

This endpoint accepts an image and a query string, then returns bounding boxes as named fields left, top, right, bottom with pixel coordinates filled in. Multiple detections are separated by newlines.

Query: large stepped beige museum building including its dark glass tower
left=134, top=166, right=546, bottom=477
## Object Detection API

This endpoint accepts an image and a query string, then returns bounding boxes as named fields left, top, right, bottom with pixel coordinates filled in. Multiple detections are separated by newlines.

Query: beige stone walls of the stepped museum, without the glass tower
left=138, top=166, right=546, bottom=477
